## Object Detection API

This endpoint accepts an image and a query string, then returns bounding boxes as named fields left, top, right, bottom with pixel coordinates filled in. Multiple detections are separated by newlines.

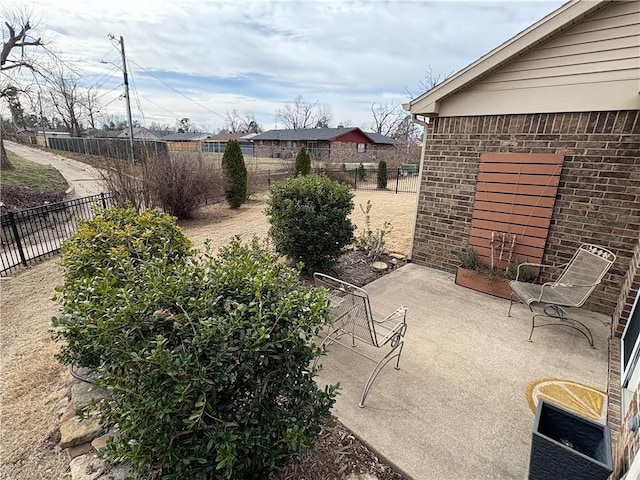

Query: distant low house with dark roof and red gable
left=251, top=127, right=398, bottom=163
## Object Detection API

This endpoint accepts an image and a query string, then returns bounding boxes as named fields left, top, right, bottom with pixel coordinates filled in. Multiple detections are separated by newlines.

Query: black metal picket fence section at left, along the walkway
left=0, top=193, right=114, bottom=276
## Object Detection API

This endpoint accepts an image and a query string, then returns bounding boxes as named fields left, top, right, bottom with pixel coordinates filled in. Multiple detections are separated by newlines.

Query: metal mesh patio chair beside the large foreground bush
left=313, top=273, right=407, bottom=407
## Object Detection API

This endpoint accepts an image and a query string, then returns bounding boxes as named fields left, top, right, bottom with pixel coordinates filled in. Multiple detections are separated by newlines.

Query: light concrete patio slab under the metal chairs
left=319, top=264, right=610, bottom=480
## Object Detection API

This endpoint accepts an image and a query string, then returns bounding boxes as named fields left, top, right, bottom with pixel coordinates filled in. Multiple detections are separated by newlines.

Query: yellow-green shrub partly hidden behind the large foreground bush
left=54, top=208, right=192, bottom=367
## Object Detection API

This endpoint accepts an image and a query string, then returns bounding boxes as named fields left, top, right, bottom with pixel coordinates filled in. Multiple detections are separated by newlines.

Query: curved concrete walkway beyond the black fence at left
left=4, top=140, right=105, bottom=199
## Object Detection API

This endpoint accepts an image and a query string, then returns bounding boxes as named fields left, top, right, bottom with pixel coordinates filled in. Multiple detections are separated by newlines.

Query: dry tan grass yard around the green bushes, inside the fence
left=0, top=191, right=415, bottom=480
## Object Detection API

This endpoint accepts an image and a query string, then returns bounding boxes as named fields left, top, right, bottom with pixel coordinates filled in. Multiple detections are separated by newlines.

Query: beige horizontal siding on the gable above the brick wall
left=439, top=0, right=640, bottom=117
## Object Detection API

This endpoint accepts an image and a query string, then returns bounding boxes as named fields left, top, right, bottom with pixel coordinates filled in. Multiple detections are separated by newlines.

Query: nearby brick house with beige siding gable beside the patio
left=405, top=0, right=640, bottom=480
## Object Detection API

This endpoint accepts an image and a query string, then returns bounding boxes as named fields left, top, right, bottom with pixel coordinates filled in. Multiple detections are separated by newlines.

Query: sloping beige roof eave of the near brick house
left=403, top=0, right=613, bottom=117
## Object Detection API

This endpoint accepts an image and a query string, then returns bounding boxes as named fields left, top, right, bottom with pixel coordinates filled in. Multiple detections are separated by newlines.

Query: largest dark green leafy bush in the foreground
left=52, top=238, right=335, bottom=480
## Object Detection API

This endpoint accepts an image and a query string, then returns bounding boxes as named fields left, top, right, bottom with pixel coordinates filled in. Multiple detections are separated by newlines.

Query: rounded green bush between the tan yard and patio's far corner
left=266, top=175, right=355, bottom=272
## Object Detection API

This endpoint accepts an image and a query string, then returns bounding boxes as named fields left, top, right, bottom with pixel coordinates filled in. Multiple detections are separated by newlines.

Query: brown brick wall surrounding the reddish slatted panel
left=412, top=111, right=640, bottom=314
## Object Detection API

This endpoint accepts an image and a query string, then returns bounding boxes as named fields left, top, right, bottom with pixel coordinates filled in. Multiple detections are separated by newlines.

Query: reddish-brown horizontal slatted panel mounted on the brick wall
left=469, top=153, right=564, bottom=268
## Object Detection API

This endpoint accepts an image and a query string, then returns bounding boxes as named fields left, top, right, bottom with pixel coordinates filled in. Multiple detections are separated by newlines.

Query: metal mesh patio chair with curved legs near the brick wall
left=507, top=243, right=616, bottom=348
